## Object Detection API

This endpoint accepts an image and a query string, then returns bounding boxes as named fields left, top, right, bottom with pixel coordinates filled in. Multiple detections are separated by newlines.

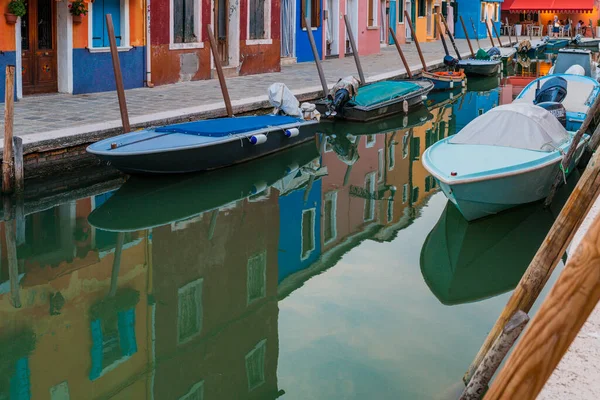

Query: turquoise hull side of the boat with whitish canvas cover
left=439, top=140, right=587, bottom=221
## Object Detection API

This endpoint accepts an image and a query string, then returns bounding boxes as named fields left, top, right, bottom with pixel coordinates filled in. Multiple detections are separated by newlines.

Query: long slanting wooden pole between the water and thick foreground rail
left=463, top=139, right=600, bottom=383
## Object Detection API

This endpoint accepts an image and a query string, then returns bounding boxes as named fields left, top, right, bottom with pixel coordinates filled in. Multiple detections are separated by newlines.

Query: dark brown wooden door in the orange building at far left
left=21, top=0, right=58, bottom=95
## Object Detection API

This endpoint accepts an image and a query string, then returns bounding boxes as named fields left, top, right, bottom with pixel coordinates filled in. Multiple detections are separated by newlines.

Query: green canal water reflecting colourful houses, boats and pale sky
left=0, top=74, right=568, bottom=400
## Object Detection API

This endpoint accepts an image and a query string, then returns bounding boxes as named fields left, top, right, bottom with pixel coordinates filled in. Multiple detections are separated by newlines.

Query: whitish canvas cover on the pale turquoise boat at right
left=449, top=103, right=569, bottom=152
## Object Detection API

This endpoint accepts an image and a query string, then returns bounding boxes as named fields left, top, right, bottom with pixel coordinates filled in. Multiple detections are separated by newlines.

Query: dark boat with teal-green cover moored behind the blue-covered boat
left=315, top=80, right=433, bottom=121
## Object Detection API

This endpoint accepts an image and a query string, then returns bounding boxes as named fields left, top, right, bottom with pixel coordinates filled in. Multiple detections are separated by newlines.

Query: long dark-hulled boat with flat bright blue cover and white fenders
left=87, top=115, right=318, bottom=174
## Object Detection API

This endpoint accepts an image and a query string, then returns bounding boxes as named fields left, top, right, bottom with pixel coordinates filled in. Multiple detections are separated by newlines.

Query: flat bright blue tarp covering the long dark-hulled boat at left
left=155, top=115, right=303, bottom=137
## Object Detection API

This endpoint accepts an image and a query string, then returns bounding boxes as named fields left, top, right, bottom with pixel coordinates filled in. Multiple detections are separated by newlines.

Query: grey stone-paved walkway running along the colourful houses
left=0, top=39, right=494, bottom=136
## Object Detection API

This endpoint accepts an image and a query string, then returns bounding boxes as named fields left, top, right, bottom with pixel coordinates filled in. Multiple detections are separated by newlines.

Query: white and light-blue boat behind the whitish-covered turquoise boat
left=515, top=73, right=600, bottom=131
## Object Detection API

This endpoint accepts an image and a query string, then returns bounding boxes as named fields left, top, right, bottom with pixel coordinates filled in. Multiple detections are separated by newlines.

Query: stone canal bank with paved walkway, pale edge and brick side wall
left=0, top=39, right=496, bottom=178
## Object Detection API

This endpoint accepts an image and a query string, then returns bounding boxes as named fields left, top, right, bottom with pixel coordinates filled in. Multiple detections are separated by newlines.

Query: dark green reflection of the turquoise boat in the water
left=421, top=171, right=578, bottom=305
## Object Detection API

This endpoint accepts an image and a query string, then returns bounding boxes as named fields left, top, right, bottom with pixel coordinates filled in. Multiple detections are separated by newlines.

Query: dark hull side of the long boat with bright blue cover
left=88, top=123, right=318, bottom=174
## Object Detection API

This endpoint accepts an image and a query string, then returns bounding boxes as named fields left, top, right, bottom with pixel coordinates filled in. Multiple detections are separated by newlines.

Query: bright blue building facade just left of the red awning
left=454, top=0, right=504, bottom=39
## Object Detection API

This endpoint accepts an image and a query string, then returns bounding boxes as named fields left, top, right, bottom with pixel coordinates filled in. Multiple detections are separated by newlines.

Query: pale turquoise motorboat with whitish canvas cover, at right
left=422, top=103, right=589, bottom=221
